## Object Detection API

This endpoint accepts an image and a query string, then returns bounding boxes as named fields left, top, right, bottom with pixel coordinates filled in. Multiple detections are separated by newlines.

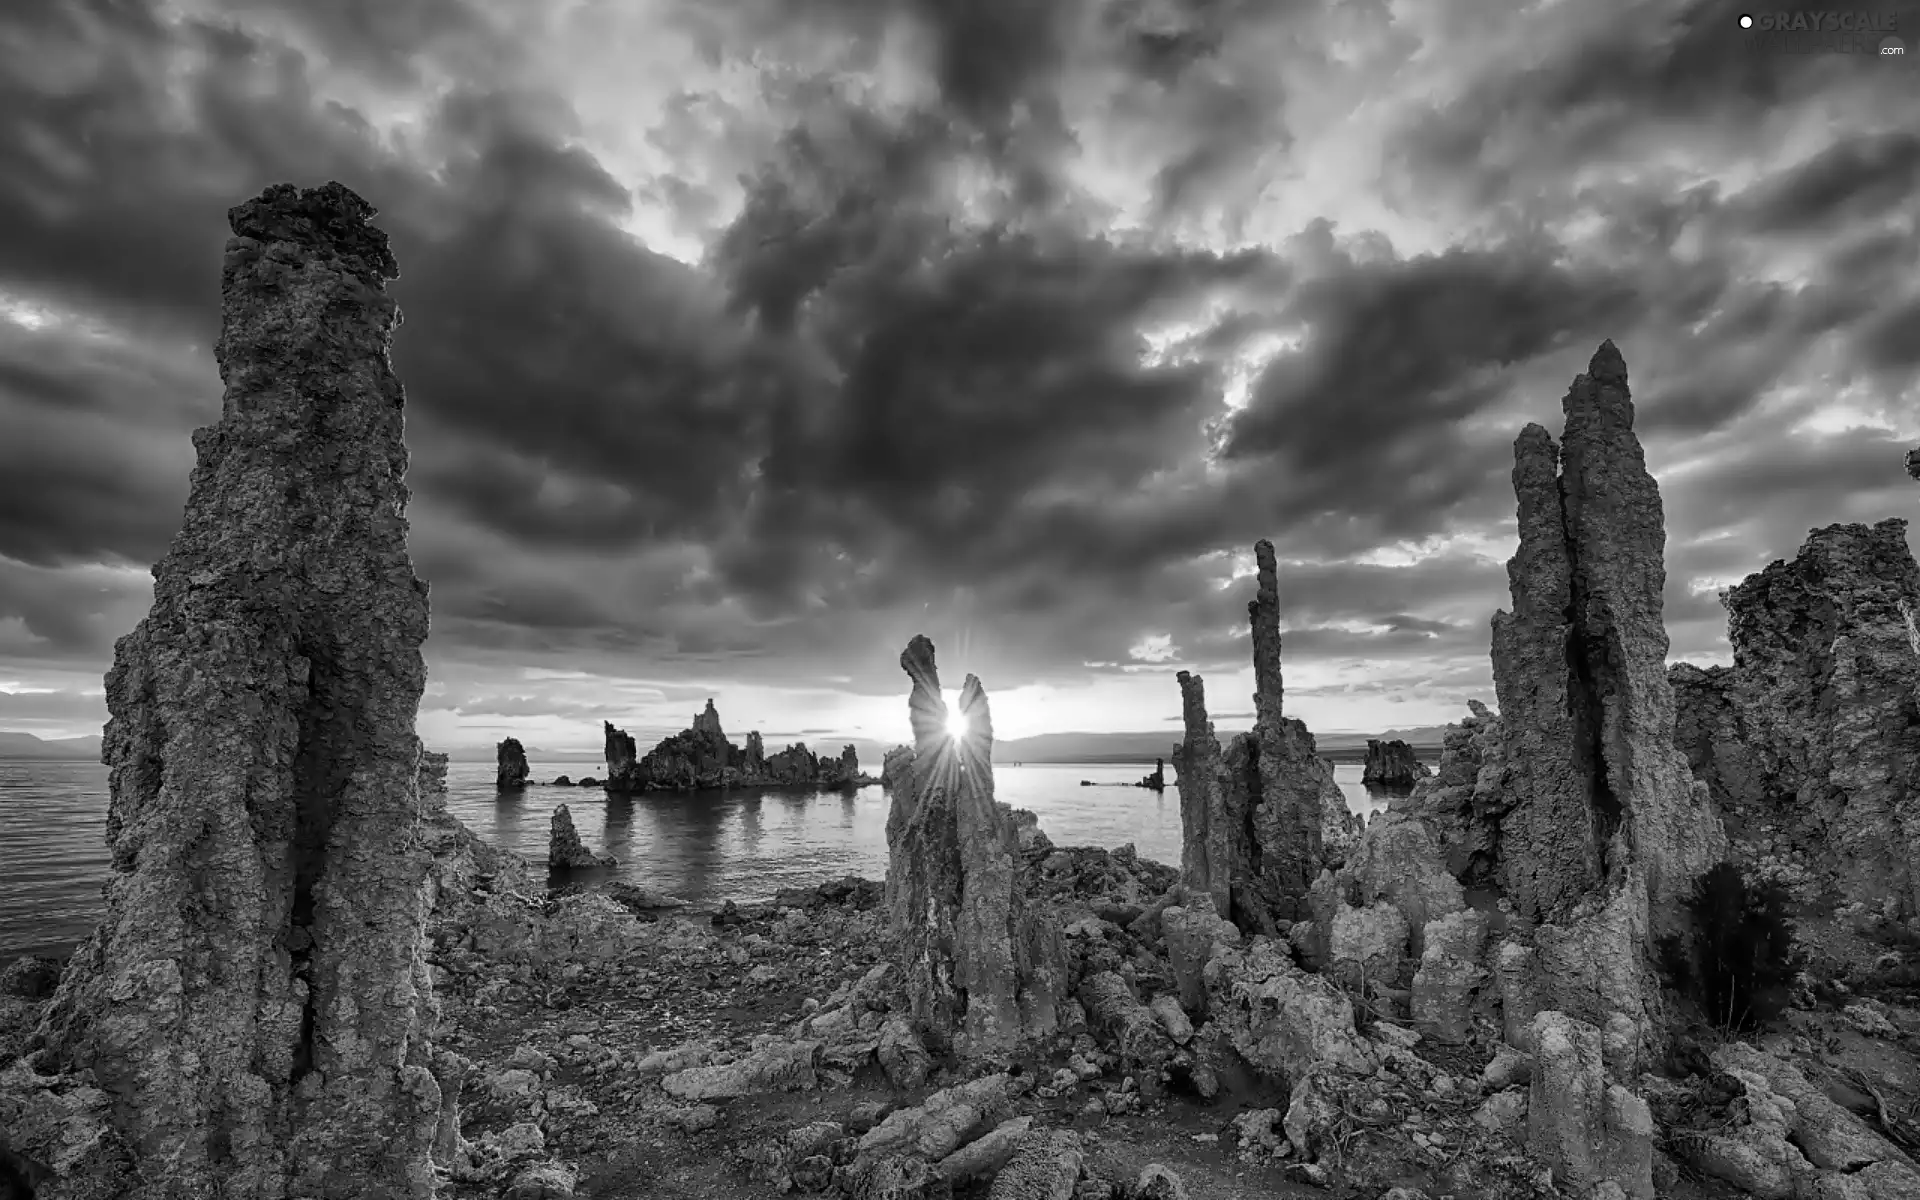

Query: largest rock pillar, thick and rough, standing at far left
left=22, top=184, right=440, bottom=1198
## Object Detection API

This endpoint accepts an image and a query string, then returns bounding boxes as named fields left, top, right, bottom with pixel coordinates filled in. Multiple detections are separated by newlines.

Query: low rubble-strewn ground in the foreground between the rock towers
left=0, top=847, right=1920, bottom=1200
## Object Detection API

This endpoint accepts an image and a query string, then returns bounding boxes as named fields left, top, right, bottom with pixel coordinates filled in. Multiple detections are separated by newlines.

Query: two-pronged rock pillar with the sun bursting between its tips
left=887, top=637, right=1068, bottom=1054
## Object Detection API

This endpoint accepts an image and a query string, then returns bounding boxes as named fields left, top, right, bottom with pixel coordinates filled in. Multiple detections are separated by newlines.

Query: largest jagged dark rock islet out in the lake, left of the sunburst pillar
left=605, top=701, right=874, bottom=791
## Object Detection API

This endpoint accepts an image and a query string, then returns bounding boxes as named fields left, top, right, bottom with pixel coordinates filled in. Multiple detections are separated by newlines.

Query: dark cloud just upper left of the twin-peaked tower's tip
left=1219, top=230, right=1640, bottom=538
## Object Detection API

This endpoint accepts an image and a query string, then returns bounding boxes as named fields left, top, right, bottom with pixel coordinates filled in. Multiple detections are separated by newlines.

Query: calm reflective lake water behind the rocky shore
left=0, top=760, right=1413, bottom=962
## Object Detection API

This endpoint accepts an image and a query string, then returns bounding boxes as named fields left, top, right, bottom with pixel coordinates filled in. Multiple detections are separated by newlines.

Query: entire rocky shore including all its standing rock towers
left=0, top=184, right=1920, bottom=1200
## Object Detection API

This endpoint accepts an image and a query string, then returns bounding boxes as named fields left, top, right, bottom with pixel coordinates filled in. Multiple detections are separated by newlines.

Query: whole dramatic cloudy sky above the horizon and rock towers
left=0, top=0, right=1920, bottom=747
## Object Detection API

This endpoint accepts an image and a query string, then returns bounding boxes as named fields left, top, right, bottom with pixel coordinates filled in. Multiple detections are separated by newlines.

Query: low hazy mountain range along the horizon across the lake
left=0, top=726, right=1446, bottom=774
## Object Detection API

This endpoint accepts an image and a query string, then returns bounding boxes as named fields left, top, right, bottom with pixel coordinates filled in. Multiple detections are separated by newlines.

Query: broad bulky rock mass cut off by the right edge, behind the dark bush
left=1670, top=518, right=1920, bottom=920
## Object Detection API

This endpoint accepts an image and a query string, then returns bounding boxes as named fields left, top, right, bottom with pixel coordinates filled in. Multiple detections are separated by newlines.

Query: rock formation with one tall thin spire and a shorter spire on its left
left=1173, top=540, right=1359, bottom=931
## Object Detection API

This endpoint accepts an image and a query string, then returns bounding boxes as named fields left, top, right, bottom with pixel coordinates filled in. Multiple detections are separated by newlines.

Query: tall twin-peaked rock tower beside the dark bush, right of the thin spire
left=1494, top=342, right=1726, bottom=933
